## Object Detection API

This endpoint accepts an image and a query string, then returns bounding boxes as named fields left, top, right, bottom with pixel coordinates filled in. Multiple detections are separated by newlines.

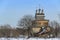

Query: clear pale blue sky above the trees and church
left=0, top=0, right=60, bottom=26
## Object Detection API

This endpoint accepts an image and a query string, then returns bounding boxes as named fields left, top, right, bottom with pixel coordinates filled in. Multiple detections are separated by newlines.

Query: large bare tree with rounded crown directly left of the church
left=18, top=15, right=34, bottom=37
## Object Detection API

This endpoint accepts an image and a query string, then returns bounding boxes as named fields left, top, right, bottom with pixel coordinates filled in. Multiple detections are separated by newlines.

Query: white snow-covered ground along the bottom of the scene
left=0, top=38, right=60, bottom=40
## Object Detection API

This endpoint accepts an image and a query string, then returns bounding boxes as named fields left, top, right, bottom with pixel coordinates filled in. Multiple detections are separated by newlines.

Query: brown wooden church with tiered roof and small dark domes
left=31, top=9, right=51, bottom=37
